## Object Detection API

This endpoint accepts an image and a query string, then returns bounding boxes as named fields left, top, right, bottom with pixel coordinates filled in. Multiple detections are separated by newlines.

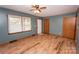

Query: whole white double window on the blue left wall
left=8, top=15, right=31, bottom=33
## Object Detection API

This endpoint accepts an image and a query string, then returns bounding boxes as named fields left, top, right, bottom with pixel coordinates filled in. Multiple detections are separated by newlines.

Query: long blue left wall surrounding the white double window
left=0, top=8, right=42, bottom=44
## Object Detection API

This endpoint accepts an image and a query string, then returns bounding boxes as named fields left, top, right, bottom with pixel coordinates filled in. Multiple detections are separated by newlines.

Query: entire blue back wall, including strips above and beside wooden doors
left=43, top=13, right=76, bottom=36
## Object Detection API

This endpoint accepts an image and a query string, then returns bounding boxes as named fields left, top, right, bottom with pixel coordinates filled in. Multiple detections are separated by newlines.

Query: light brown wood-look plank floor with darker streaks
left=0, top=34, right=76, bottom=54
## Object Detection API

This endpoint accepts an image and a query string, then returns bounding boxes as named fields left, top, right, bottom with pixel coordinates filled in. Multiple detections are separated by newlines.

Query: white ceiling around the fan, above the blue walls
left=0, top=5, right=79, bottom=17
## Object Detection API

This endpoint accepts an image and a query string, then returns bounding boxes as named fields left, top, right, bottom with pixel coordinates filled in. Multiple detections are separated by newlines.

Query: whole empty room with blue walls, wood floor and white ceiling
left=0, top=5, right=79, bottom=54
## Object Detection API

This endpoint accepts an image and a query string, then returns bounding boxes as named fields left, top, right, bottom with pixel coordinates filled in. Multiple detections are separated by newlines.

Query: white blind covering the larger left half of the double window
left=8, top=15, right=22, bottom=33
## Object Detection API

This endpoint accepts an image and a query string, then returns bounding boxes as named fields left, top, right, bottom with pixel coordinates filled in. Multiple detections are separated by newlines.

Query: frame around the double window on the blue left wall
left=7, top=14, right=32, bottom=35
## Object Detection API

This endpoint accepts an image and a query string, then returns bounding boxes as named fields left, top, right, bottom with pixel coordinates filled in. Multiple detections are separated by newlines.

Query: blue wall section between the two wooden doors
left=50, top=16, right=63, bottom=35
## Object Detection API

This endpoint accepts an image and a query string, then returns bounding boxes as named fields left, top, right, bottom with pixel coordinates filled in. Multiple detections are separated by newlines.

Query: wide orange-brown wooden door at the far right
left=63, top=17, right=76, bottom=39
